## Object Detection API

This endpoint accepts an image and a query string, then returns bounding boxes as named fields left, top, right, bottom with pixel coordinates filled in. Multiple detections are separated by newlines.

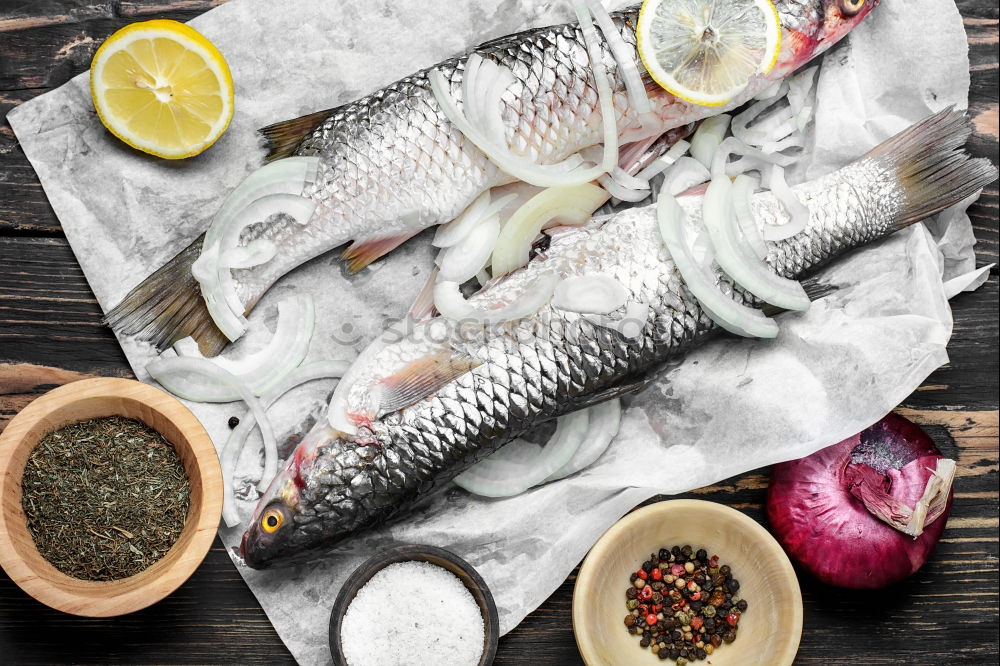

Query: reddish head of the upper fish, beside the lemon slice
left=769, top=0, right=879, bottom=73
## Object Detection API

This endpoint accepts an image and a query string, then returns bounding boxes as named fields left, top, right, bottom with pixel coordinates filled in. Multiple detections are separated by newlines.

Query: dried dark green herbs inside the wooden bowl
left=21, top=416, right=191, bottom=580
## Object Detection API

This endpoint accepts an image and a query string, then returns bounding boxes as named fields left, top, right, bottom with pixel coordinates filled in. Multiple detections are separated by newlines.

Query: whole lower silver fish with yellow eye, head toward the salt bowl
left=241, top=110, right=996, bottom=568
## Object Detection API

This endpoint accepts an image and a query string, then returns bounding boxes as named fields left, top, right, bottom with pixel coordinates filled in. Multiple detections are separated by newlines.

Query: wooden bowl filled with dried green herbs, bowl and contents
left=0, top=378, right=222, bottom=617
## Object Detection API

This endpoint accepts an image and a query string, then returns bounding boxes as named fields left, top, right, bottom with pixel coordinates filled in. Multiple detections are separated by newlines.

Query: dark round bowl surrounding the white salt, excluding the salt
left=330, top=546, right=500, bottom=666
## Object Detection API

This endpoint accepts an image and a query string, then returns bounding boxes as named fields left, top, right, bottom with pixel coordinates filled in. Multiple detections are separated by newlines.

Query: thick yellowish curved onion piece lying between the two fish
left=492, top=183, right=608, bottom=276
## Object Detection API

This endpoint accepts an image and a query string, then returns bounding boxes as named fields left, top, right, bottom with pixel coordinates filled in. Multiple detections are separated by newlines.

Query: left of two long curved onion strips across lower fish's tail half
left=656, top=192, right=778, bottom=338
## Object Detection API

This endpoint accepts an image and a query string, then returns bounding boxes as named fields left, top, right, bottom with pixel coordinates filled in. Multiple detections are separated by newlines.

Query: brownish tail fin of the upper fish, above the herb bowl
left=104, top=234, right=229, bottom=356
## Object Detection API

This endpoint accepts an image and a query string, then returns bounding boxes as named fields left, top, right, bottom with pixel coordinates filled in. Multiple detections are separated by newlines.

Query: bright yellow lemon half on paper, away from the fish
left=90, top=20, right=233, bottom=159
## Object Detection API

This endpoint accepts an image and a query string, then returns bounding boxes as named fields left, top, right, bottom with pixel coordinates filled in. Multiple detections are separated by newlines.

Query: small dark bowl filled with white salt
left=330, top=545, right=500, bottom=666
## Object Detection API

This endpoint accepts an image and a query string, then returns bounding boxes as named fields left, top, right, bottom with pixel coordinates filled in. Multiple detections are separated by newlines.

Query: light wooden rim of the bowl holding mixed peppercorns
left=573, top=499, right=802, bottom=666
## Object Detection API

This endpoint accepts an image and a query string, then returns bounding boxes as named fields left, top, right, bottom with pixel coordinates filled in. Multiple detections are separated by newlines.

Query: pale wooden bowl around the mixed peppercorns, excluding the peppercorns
left=573, top=500, right=802, bottom=666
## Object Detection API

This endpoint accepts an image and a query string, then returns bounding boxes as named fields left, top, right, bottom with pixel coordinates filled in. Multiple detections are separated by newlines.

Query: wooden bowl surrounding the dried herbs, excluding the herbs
left=0, top=378, right=222, bottom=617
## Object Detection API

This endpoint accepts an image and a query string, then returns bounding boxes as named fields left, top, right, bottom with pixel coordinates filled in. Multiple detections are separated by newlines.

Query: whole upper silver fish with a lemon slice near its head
left=106, top=0, right=878, bottom=354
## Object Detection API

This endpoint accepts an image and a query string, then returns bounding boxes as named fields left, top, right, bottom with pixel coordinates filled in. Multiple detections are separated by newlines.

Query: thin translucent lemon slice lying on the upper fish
left=636, top=0, right=781, bottom=106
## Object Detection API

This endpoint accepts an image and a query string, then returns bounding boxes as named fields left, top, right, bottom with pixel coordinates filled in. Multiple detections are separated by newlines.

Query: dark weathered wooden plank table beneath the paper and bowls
left=0, top=0, right=998, bottom=666
